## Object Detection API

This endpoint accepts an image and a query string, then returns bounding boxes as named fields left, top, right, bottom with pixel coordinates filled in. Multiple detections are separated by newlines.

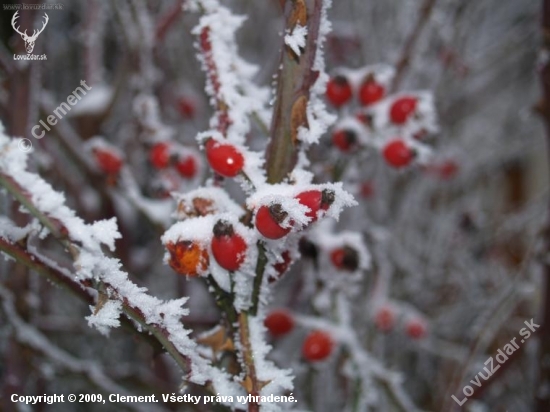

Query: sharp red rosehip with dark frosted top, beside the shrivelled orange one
left=211, top=220, right=247, bottom=272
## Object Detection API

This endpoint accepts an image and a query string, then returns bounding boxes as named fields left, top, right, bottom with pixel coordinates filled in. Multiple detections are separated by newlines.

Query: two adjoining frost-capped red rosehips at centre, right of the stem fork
left=255, top=189, right=334, bottom=239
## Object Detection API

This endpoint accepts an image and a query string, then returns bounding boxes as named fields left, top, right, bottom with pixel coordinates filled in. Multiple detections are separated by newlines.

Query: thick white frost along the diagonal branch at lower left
left=0, top=124, right=242, bottom=402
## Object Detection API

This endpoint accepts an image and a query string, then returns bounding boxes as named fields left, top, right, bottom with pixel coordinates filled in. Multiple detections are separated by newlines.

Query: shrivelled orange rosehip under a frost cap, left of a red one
left=166, top=241, right=209, bottom=276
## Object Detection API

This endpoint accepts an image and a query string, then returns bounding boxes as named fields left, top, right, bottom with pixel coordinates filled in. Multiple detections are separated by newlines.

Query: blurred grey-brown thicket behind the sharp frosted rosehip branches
left=0, top=0, right=549, bottom=412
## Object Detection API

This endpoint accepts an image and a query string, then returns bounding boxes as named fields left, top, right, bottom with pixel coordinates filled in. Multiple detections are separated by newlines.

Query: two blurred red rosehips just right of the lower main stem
left=264, top=309, right=334, bottom=362
